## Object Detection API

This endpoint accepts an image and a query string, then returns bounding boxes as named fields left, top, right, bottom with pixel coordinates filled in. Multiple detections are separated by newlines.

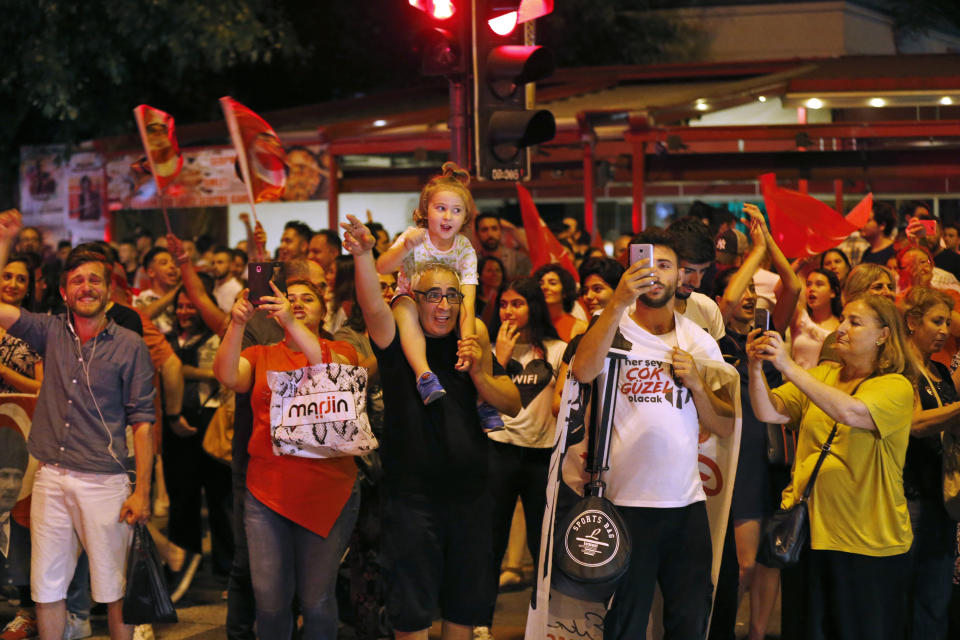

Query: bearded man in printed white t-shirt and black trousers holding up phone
left=571, top=229, right=734, bottom=640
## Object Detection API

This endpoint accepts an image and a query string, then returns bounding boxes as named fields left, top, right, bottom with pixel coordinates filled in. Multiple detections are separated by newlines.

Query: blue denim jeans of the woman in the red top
left=245, top=485, right=360, bottom=640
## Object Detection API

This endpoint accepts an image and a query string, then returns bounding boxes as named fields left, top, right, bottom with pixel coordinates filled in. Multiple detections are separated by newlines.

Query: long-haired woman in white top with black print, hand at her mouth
left=476, top=278, right=566, bottom=626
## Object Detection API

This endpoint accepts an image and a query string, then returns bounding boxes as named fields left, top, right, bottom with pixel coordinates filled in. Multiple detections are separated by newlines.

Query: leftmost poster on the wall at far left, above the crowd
left=20, top=145, right=67, bottom=227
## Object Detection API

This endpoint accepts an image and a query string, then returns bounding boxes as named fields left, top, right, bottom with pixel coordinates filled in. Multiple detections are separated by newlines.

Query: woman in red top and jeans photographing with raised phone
left=214, top=280, right=360, bottom=640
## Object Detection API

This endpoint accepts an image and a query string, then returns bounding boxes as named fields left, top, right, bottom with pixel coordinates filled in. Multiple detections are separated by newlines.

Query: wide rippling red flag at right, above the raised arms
left=760, top=173, right=873, bottom=258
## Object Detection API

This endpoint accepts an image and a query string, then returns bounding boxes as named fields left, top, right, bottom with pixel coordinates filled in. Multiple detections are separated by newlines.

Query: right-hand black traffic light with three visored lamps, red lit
left=473, top=0, right=556, bottom=181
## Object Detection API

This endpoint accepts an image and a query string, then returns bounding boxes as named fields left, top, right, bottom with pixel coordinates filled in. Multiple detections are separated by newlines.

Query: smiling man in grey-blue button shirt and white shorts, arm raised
left=0, top=211, right=155, bottom=640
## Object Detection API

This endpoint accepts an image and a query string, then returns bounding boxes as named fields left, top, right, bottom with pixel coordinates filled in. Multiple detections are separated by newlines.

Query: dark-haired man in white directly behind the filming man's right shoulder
left=669, top=217, right=725, bottom=340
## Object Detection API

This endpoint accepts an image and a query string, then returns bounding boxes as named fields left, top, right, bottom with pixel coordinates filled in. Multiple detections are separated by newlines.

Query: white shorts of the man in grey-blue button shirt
left=30, top=465, right=133, bottom=603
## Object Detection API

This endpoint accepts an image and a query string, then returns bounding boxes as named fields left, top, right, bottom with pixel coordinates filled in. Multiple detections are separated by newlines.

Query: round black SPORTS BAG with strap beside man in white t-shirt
left=551, top=354, right=631, bottom=602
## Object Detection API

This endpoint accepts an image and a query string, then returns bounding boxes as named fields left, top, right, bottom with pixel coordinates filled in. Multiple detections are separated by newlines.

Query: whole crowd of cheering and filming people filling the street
left=0, top=168, right=960, bottom=640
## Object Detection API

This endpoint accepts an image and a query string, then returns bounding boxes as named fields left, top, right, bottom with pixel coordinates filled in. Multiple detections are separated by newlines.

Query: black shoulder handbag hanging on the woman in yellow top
left=757, top=420, right=840, bottom=569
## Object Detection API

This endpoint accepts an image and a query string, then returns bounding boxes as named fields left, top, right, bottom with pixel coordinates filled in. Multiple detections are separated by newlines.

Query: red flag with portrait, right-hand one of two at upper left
left=220, top=97, right=287, bottom=203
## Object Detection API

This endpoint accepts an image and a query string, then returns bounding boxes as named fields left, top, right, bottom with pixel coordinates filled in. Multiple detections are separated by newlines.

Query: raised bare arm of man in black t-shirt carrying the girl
left=340, top=215, right=397, bottom=349
